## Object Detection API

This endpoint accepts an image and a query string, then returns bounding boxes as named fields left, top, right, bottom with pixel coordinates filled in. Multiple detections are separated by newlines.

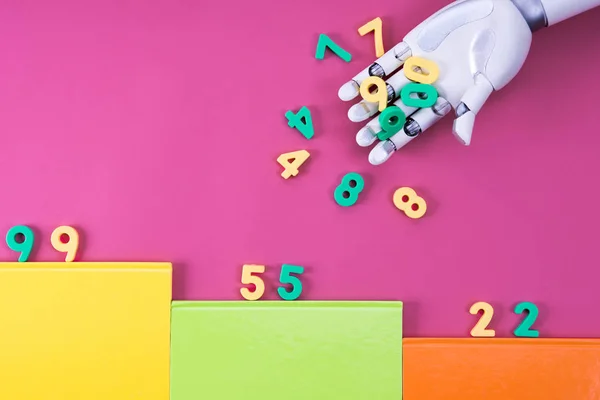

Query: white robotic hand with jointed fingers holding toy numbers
left=338, top=0, right=600, bottom=165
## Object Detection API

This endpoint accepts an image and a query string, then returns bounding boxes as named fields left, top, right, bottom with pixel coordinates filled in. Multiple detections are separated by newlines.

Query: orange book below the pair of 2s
left=403, top=338, right=600, bottom=400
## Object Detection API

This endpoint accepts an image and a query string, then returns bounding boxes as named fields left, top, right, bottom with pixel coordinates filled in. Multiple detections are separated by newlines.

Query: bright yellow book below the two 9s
left=0, top=262, right=172, bottom=400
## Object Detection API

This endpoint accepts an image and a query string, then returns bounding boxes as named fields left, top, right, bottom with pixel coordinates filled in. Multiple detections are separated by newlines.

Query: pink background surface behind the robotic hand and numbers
left=0, top=0, right=600, bottom=337
